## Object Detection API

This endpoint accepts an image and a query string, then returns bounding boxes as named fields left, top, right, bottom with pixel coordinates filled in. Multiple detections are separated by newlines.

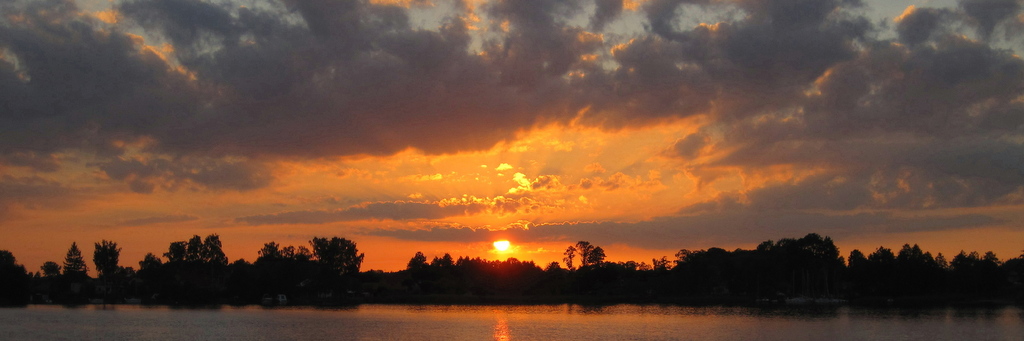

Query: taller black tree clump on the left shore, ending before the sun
left=0, top=235, right=364, bottom=305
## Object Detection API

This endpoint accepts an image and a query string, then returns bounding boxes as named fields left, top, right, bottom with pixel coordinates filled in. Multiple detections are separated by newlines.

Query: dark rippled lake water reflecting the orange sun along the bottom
left=0, top=304, right=1024, bottom=341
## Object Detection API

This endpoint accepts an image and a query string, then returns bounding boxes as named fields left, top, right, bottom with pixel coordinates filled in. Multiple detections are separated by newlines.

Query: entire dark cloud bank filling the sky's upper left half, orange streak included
left=0, top=0, right=577, bottom=169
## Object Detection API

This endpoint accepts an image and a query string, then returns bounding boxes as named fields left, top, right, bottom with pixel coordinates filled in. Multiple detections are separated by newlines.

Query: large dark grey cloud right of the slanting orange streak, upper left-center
left=122, top=0, right=575, bottom=157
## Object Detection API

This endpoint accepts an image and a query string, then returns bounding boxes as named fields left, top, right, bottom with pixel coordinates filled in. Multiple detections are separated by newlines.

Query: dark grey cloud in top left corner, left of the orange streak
left=0, top=0, right=202, bottom=156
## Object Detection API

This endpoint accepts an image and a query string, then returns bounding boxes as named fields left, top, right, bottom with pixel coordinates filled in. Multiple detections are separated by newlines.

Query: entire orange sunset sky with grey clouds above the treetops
left=0, top=0, right=1024, bottom=270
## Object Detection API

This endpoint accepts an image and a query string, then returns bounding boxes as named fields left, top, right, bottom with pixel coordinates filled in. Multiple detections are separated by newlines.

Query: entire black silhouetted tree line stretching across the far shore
left=0, top=233, right=1024, bottom=305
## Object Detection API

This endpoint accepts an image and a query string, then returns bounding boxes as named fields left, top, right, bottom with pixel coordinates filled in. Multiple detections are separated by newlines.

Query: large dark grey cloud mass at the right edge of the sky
left=675, top=28, right=1024, bottom=210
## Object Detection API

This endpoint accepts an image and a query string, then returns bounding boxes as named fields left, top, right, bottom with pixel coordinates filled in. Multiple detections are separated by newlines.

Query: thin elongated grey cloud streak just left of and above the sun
left=234, top=202, right=487, bottom=225
